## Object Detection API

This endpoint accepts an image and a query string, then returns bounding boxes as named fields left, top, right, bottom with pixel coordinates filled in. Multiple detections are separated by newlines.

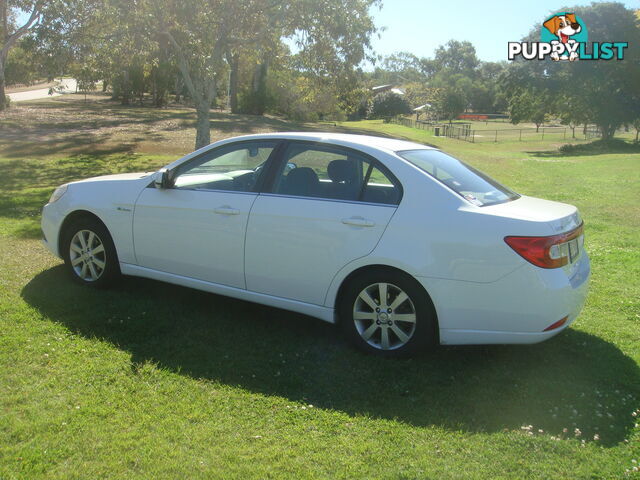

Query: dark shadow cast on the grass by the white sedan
left=22, top=266, right=640, bottom=446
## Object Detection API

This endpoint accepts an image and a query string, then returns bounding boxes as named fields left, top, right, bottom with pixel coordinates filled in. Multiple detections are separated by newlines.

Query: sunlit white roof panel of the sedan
left=220, top=132, right=433, bottom=152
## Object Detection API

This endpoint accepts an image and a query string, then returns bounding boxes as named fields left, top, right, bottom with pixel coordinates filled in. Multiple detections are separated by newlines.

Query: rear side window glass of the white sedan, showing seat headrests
left=274, top=144, right=400, bottom=205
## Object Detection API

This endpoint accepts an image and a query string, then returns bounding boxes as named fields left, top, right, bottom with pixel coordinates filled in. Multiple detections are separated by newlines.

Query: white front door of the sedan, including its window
left=133, top=141, right=276, bottom=288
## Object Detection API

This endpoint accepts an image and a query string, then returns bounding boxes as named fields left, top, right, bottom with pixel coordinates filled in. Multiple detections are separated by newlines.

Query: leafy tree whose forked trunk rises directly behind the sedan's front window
left=145, top=0, right=380, bottom=148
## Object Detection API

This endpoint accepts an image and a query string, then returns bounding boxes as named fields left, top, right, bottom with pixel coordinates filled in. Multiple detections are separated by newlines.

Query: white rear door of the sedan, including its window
left=245, top=142, right=401, bottom=305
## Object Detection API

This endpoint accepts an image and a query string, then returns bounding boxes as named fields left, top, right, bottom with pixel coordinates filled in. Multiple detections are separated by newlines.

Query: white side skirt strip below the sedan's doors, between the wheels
left=120, top=262, right=336, bottom=323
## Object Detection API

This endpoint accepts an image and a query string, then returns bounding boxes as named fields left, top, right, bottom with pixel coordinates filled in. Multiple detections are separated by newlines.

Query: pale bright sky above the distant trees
left=371, top=0, right=640, bottom=61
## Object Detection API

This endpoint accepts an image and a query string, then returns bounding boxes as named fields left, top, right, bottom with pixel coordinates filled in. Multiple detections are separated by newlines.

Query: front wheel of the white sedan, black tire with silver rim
left=61, top=217, right=120, bottom=288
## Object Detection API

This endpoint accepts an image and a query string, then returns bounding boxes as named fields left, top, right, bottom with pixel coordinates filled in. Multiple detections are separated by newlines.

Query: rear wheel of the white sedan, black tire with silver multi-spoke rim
left=337, top=270, right=438, bottom=357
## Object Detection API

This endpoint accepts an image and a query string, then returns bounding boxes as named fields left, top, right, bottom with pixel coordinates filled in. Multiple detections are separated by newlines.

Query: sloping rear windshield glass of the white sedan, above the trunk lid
left=396, top=149, right=520, bottom=207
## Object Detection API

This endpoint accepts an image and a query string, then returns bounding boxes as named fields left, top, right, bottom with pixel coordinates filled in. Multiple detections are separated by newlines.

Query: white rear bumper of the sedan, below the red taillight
left=418, top=252, right=590, bottom=345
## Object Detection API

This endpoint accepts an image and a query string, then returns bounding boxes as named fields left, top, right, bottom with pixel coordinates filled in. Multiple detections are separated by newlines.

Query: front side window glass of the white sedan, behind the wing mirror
left=173, top=142, right=275, bottom=192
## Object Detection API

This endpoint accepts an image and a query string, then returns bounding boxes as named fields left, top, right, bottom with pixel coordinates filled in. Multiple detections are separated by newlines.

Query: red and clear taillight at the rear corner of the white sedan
left=504, top=224, right=583, bottom=268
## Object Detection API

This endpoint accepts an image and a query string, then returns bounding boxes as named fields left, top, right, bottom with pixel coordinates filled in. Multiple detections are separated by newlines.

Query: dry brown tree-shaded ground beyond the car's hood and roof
left=0, top=94, right=324, bottom=158
